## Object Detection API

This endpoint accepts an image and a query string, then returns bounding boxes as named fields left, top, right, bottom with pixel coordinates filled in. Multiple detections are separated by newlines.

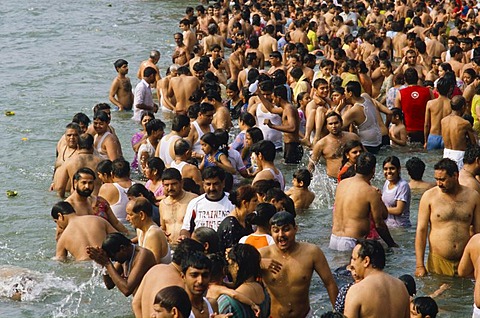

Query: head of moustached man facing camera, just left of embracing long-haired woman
left=181, top=252, right=212, bottom=297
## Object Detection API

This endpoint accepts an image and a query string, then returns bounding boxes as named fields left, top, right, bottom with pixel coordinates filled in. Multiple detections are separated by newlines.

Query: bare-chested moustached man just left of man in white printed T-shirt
left=159, top=168, right=197, bottom=244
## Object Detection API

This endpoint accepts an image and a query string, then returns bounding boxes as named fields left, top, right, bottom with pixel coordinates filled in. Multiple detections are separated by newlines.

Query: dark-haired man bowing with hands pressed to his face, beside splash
left=87, top=233, right=156, bottom=297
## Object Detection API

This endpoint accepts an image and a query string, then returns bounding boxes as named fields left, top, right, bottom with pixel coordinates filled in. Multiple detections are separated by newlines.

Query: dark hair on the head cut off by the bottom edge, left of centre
left=153, top=286, right=192, bottom=317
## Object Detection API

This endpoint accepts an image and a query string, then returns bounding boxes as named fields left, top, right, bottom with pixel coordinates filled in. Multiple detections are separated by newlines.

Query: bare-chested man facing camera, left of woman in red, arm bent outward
left=308, top=111, right=360, bottom=179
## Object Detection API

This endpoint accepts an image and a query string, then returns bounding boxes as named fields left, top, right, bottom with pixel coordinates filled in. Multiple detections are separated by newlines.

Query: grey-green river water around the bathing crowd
left=0, top=0, right=473, bottom=317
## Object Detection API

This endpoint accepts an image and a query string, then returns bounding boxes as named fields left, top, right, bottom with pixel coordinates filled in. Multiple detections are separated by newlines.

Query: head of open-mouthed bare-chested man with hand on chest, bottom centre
left=270, top=211, right=298, bottom=251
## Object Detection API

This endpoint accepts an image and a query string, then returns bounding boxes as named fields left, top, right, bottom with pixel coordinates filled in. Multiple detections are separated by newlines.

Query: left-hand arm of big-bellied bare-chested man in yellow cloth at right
left=415, top=189, right=435, bottom=276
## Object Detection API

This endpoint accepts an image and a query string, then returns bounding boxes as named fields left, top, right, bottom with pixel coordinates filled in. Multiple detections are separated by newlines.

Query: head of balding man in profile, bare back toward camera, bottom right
left=350, top=240, right=385, bottom=279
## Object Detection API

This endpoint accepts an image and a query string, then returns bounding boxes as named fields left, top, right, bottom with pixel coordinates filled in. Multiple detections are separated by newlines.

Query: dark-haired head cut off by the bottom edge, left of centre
left=151, top=286, right=192, bottom=318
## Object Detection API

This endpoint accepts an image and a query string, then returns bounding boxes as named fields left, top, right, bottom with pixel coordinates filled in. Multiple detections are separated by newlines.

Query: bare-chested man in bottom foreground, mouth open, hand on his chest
left=260, top=212, right=338, bottom=318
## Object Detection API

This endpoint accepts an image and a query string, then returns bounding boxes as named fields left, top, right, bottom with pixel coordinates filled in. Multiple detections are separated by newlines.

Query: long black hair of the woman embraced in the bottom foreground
left=228, top=244, right=261, bottom=288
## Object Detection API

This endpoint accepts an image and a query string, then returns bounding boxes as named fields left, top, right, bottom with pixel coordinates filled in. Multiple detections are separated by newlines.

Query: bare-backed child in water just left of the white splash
left=285, top=169, right=315, bottom=210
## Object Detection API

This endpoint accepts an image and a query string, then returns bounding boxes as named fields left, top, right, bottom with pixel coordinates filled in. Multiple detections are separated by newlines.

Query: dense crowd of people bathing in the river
left=42, top=0, right=480, bottom=318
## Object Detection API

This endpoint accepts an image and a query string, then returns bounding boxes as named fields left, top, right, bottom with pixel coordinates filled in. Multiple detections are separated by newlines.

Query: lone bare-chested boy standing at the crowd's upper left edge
left=109, top=59, right=133, bottom=111
